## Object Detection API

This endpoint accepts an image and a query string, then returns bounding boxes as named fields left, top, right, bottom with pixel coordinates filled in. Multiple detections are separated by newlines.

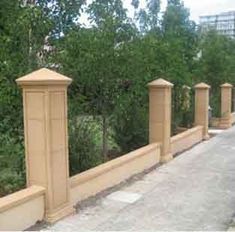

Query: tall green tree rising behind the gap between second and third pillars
left=161, top=0, right=198, bottom=129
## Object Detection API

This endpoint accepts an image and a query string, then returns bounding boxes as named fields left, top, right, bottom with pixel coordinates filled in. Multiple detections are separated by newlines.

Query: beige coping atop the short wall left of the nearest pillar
left=0, top=185, right=45, bottom=213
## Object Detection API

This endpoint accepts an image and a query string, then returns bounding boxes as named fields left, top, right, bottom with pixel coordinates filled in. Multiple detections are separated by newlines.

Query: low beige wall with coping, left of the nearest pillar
left=0, top=186, right=45, bottom=231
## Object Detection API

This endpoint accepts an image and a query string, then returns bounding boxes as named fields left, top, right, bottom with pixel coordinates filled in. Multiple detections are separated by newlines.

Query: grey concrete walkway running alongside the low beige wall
left=47, top=127, right=235, bottom=231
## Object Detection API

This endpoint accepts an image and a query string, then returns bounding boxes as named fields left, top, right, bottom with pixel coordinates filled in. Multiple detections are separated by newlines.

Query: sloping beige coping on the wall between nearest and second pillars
left=70, top=143, right=161, bottom=188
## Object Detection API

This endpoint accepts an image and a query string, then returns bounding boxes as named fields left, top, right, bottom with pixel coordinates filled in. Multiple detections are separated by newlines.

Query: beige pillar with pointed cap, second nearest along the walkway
left=148, top=79, right=173, bottom=162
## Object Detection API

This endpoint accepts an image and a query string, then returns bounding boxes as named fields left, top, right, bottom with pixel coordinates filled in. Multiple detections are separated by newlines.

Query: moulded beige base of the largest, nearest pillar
left=46, top=205, right=76, bottom=224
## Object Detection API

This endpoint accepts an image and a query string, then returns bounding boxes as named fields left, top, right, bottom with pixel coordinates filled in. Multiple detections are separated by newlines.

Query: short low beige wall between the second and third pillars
left=171, top=126, right=203, bottom=155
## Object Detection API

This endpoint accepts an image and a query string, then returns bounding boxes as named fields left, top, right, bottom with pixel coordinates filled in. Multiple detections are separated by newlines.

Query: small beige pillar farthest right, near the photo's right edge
left=220, top=83, right=233, bottom=129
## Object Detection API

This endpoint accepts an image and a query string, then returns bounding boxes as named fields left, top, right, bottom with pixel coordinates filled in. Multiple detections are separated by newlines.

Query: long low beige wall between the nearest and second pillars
left=70, top=143, right=160, bottom=205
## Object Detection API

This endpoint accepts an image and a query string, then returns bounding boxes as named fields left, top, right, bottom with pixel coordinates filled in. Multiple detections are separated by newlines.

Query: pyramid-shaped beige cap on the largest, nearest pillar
left=16, top=68, right=72, bottom=86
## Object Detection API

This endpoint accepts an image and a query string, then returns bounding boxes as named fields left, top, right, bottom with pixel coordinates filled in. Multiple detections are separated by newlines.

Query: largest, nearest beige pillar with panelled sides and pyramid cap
left=16, top=68, right=74, bottom=223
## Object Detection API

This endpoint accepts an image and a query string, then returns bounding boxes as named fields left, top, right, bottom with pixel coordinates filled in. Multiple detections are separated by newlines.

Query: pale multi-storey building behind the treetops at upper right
left=200, top=11, right=235, bottom=38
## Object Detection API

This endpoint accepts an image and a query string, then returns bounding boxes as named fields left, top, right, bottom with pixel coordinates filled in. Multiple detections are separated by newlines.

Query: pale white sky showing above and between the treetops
left=81, top=0, right=235, bottom=24
